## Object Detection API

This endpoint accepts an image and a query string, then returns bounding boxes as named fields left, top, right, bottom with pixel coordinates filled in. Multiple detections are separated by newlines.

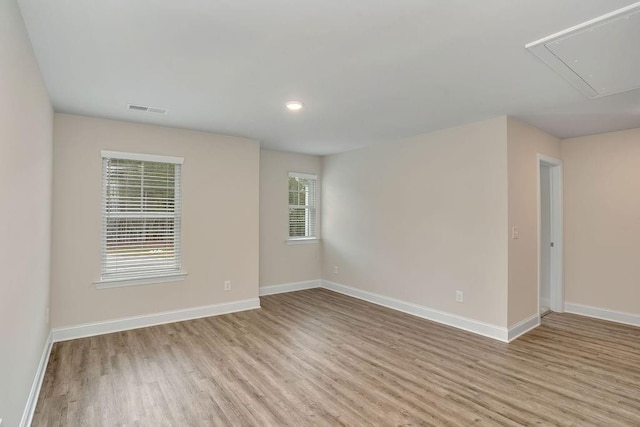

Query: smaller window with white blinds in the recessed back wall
left=289, top=172, right=318, bottom=239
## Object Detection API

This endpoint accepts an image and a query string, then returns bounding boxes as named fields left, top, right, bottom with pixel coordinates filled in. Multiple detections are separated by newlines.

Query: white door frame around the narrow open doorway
left=537, top=154, right=564, bottom=316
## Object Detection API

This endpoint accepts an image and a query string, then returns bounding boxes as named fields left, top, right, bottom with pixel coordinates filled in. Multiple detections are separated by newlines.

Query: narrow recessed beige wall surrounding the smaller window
left=260, top=150, right=322, bottom=286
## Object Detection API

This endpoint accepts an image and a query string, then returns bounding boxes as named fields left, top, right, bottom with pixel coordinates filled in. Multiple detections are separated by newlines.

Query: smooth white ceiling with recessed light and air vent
left=19, top=0, right=640, bottom=154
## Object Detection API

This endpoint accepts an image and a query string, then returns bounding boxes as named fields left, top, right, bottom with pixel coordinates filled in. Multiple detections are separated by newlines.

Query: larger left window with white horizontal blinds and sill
left=96, top=151, right=184, bottom=287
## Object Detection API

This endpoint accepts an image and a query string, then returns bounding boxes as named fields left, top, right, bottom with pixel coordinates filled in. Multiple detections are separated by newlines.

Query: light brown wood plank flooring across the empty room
left=33, top=289, right=640, bottom=426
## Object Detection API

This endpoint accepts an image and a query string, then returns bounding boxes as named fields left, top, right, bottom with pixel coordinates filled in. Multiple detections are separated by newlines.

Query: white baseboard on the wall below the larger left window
left=51, top=298, right=260, bottom=342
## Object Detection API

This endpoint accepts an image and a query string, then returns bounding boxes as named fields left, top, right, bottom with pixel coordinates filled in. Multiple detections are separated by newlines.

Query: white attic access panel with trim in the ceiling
left=525, top=2, right=640, bottom=98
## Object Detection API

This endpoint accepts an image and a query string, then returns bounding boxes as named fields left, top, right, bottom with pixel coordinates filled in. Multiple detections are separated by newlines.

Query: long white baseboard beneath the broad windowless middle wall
left=322, top=280, right=509, bottom=342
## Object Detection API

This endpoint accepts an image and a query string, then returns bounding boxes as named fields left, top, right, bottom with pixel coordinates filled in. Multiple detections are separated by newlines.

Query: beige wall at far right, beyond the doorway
left=561, top=129, right=640, bottom=315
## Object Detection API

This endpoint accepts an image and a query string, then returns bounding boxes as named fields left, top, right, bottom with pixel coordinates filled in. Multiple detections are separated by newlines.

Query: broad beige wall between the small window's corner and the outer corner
left=322, top=117, right=507, bottom=327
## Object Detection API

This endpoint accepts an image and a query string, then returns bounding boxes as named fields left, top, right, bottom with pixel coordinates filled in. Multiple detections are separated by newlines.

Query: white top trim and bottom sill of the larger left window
left=93, top=150, right=188, bottom=289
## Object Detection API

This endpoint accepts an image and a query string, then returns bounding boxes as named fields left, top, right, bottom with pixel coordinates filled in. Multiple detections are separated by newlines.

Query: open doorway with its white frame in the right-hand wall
left=538, top=154, right=564, bottom=317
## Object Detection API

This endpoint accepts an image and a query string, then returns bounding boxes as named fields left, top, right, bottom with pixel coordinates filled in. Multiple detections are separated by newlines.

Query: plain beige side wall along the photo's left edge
left=0, top=0, right=53, bottom=426
